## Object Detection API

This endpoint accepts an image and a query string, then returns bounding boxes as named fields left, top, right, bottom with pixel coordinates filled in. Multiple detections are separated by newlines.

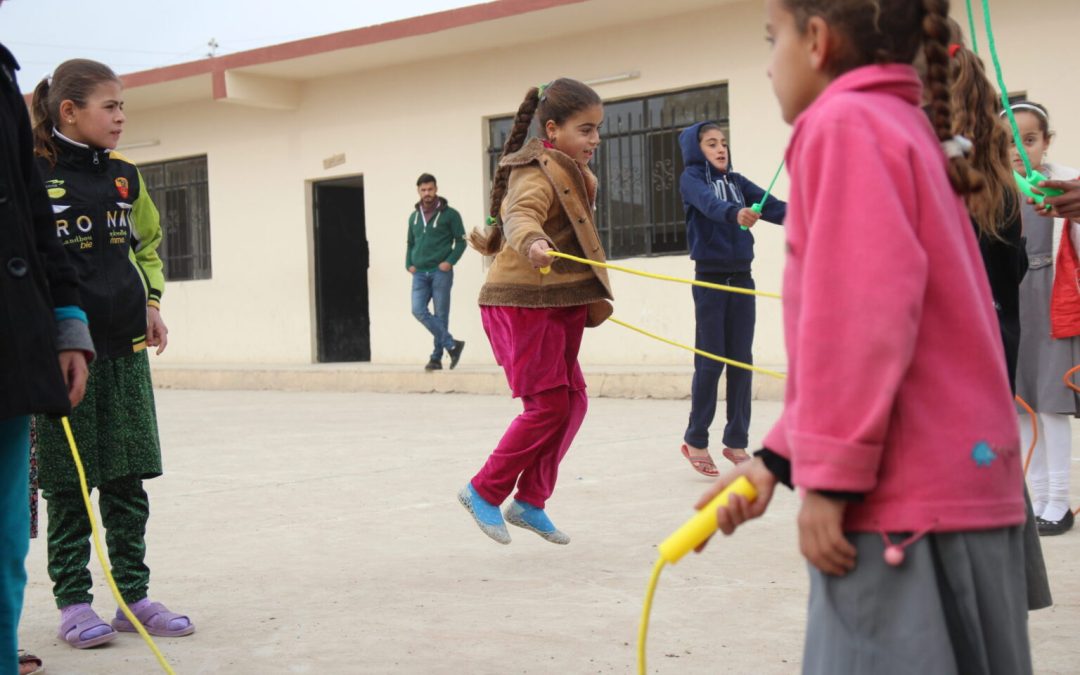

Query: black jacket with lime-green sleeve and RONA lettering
left=38, top=132, right=164, bottom=359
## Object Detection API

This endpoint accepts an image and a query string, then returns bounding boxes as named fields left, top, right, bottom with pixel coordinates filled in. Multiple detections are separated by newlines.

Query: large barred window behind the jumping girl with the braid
left=487, top=79, right=730, bottom=259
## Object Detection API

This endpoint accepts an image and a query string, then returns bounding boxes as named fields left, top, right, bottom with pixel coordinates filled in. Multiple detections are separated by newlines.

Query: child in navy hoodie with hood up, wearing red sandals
left=678, top=122, right=787, bottom=476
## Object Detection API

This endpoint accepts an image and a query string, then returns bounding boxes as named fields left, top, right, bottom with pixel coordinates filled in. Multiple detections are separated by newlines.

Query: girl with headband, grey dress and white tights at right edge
left=1012, top=102, right=1080, bottom=536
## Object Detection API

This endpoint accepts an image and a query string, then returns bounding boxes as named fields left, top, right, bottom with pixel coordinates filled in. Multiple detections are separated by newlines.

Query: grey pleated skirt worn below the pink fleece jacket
left=802, top=526, right=1031, bottom=675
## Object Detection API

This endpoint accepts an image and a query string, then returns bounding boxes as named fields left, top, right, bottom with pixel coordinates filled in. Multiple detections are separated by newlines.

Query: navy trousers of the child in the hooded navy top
left=683, top=272, right=757, bottom=448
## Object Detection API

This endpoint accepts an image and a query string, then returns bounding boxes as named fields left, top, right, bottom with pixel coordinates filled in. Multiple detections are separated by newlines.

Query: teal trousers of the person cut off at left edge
left=0, top=417, right=30, bottom=675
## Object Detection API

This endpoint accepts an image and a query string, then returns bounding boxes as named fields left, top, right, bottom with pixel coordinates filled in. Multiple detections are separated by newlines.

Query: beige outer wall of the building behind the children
left=118, top=0, right=1080, bottom=365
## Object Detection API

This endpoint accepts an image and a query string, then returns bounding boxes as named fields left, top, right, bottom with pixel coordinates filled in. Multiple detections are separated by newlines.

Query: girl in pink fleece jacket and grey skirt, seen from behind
left=699, top=0, right=1031, bottom=675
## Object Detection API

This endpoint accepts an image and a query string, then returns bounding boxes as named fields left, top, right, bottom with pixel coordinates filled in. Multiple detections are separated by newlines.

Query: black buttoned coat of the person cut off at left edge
left=0, top=45, right=79, bottom=419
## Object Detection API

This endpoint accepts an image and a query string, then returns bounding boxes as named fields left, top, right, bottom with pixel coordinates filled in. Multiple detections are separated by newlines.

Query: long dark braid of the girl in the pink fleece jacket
left=922, top=0, right=986, bottom=195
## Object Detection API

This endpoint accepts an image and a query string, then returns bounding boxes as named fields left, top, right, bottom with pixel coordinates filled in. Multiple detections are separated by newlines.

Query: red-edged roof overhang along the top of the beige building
left=111, top=0, right=734, bottom=110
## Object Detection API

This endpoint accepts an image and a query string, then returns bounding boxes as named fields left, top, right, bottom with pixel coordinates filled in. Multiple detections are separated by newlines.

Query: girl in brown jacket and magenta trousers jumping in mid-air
left=458, top=78, right=612, bottom=544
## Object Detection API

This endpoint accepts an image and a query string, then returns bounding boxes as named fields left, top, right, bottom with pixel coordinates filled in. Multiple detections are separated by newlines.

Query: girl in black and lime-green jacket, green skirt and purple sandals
left=32, top=59, right=194, bottom=649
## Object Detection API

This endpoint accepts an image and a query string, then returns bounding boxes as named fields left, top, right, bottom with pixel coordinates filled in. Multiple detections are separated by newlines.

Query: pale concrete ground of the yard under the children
left=19, top=390, right=1080, bottom=675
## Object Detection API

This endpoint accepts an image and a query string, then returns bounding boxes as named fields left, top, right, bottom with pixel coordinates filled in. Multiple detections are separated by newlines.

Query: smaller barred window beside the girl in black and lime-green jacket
left=139, top=156, right=211, bottom=281
